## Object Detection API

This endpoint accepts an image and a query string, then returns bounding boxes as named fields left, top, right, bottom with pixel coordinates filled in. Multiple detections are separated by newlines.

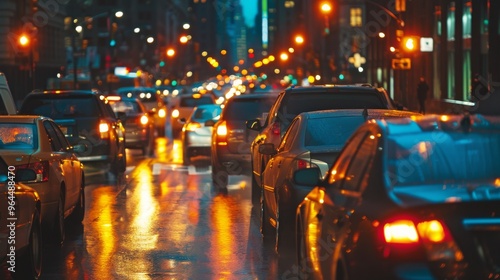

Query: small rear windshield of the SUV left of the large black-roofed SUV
left=224, top=98, right=275, bottom=121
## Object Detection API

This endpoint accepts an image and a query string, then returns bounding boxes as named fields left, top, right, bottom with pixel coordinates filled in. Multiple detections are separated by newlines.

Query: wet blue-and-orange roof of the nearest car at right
left=377, top=114, right=500, bottom=135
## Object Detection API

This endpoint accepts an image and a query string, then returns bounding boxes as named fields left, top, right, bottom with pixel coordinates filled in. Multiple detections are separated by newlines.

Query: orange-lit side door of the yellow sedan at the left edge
left=43, top=120, right=76, bottom=210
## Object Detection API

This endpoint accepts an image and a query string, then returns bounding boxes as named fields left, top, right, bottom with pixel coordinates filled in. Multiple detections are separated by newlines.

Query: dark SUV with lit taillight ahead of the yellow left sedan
left=19, top=90, right=126, bottom=174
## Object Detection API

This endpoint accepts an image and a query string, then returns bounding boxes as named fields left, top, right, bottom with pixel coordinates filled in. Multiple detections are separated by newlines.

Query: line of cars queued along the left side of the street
left=0, top=73, right=170, bottom=279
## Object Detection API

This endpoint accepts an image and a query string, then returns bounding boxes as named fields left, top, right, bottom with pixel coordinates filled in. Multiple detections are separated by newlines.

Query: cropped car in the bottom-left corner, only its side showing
left=0, top=175, right=43, bottom=279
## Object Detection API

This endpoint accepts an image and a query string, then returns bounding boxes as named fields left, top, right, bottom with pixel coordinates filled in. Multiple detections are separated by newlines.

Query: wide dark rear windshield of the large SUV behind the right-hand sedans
left=280, top=92, right=388, bottom=121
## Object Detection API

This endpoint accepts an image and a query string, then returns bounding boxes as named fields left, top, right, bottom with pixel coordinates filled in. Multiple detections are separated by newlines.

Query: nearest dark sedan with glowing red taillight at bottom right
left=294, top=115, right=500, bottom=279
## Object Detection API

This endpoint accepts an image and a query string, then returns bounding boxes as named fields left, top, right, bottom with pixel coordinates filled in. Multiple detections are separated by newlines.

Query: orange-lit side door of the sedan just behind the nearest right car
left=262, top=117, right=299, bottom=219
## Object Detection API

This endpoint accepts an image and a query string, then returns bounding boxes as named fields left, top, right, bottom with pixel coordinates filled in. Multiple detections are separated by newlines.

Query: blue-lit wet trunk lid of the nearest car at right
left=391, top=179, right=500, bottom=207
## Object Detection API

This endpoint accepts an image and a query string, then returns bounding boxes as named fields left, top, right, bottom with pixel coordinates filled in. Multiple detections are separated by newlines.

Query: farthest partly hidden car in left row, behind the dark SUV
left=116, top=87, right=167, bottom=136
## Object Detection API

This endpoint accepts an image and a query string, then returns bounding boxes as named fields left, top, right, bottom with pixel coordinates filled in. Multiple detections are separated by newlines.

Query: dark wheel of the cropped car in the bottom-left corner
left=13, top=209, right=42, bottom=279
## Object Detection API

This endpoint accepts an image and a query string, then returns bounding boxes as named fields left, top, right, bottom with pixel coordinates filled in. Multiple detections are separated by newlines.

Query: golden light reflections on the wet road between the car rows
left=38, top=139, right=300, bottom=279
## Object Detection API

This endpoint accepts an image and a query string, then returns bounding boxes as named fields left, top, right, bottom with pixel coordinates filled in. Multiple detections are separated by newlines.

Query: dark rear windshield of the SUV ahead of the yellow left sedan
left=19, top=95, right=100, bottom=119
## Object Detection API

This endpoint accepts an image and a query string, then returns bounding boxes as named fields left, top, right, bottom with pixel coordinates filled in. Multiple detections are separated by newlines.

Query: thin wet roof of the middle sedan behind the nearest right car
left=300, top=109, right=422, bottom=119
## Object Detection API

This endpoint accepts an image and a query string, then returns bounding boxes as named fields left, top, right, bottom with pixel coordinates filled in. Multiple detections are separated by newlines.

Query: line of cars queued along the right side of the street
left=202, top=82, right=500, bottom=279
